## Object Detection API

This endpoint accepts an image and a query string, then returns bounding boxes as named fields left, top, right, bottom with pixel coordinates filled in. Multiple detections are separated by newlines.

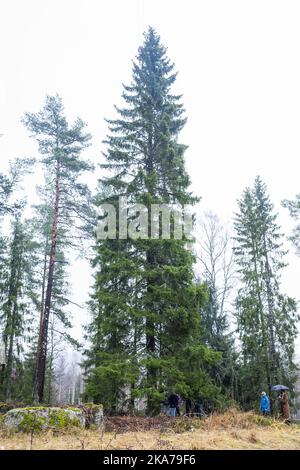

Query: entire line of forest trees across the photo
left=0, top=28, right=300, bottom=414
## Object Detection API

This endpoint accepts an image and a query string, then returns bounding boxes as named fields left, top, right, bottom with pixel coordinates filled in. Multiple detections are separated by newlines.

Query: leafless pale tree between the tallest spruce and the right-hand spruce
left=196, top=212, right=238, bottom=399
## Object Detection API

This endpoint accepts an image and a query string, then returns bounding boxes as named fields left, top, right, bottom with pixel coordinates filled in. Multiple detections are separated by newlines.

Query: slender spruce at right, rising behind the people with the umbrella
left=234, top=177, right=298, bottom=406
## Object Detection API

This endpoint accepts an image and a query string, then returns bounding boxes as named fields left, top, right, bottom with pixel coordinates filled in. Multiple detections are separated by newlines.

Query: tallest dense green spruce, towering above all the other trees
left=86, top=28, right=221, bottom=412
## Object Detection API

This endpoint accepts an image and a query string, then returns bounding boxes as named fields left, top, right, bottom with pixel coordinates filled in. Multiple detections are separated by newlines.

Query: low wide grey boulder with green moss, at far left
left=3, top=406, right=85, bottom=432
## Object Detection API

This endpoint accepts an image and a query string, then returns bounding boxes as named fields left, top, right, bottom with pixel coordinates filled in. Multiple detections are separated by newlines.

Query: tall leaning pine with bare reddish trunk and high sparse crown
left=23, top=96, right=91, bottom=402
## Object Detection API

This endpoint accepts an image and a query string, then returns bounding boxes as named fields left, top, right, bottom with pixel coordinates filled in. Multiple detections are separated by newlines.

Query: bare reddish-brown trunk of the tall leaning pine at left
left=34, top=162, right=60, bottom=403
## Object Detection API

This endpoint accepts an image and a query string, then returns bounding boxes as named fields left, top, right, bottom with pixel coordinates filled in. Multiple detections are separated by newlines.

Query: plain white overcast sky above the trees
left=0, top=0, right=300, bottom=354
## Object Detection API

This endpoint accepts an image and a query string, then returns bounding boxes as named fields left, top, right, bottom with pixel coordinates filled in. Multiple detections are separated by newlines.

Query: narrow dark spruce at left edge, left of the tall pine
left=0, top=213, right=37, bottom=400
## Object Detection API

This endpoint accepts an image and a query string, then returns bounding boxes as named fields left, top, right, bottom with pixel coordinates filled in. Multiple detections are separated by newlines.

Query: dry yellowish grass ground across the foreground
left=0, top=409, right=300, bottom=450
